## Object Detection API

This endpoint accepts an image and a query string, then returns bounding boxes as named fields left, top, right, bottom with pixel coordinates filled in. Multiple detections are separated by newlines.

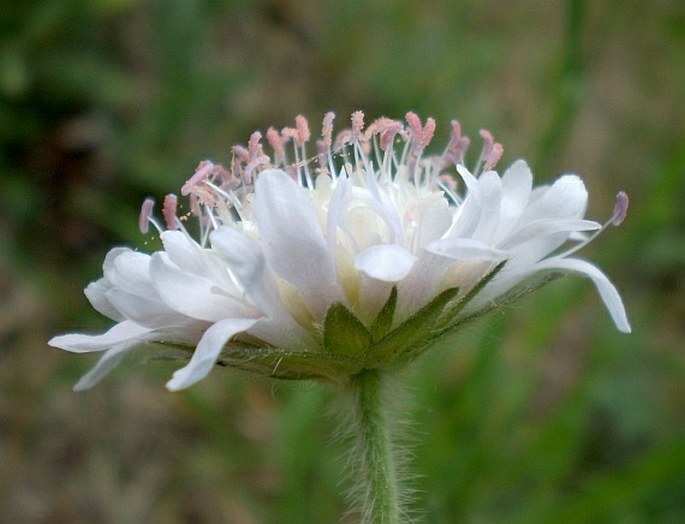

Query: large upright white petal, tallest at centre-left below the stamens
left=255, top=170, right=335, bottom=315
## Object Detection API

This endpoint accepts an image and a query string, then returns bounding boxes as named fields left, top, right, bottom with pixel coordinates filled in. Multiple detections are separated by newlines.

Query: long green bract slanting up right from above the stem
left=366, top=287, right=459, bottom=368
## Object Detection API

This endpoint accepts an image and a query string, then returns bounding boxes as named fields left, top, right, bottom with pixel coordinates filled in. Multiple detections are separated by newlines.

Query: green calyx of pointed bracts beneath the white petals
left=204, top=262, right=550, bottom=383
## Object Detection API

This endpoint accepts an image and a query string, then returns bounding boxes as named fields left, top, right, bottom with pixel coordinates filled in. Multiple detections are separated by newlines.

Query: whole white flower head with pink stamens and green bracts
left=50, top=112, right=630, bottom=390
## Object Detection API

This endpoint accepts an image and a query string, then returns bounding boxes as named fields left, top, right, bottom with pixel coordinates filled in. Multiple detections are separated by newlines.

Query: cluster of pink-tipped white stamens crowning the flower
left=139, top=111, right=627, bottom=245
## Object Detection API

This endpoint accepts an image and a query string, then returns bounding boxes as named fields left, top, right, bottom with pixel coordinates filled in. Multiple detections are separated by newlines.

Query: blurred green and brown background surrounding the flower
left=0, top=0, right=685, bottom=524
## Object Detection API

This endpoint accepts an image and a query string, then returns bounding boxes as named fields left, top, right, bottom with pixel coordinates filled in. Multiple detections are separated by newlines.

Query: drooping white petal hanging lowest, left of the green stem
left=166, top=318, right=259, bottom=391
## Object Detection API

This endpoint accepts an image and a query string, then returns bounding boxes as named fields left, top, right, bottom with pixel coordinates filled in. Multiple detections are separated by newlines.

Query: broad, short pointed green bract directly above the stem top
left=323, top=302, right=371, bottom=357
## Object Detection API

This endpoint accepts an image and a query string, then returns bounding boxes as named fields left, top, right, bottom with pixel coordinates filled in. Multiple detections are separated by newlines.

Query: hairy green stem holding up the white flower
left=352, top=370, right=400, bottom=524
